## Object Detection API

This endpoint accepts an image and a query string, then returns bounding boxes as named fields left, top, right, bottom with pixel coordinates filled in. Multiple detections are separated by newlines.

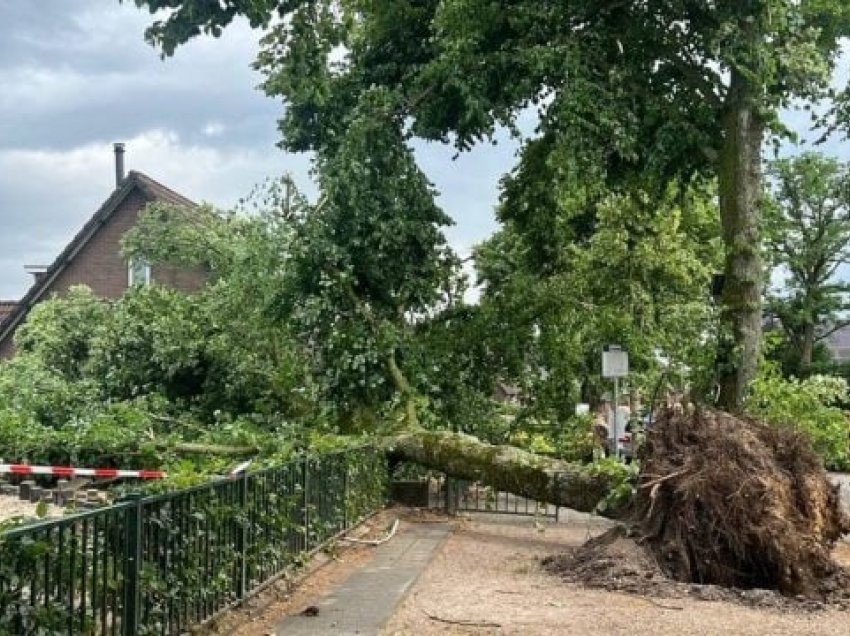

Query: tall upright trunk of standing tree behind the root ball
left=718, top=70, right=764, bottom=412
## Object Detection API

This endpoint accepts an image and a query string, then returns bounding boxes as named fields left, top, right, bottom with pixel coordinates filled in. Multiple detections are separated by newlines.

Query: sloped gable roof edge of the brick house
left=0, top=170, right=196, bottom=342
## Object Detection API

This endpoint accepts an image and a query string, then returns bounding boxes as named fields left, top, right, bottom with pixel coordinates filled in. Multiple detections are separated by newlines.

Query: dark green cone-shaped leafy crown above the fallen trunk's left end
left=268, top=85, right=458, bottom=422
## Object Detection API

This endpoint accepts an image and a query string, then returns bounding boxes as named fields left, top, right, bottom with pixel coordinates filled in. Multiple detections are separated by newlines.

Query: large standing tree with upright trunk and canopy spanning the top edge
left=126, top=0, right=850, bottom=409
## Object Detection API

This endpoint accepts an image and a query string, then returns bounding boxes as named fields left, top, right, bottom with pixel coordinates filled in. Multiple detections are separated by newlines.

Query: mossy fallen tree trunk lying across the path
left=390, top=429, right=620, bottom=515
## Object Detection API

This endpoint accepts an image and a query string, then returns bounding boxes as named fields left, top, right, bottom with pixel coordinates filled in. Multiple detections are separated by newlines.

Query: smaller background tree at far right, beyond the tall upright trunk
left=765, top=153, right=850, bottom=374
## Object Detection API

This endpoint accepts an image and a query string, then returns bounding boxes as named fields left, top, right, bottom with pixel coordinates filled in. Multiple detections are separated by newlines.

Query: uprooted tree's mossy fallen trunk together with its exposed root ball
left=390, top=409, right=850, bottom=598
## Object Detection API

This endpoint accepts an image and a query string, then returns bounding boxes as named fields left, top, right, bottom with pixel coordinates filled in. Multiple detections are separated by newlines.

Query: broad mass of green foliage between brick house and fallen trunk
left=0, top=164, right=464, bottom=470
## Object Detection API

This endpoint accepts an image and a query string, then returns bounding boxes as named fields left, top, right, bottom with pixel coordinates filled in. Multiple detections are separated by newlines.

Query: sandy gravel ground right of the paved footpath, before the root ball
left=383, top=515, right=850, bottom=636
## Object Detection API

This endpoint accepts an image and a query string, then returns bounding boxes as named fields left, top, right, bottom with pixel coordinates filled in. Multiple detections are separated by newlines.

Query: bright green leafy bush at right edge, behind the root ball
left=746, top=365, right=850, bottom=470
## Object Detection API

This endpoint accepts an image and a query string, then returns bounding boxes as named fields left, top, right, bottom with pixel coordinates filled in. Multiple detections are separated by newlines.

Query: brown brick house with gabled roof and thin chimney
left=0, top=144, right=207, bottom=359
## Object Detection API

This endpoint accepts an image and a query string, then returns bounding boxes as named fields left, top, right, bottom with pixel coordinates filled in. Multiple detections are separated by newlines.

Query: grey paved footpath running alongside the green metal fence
left=275, top=523, right=449, bottom=636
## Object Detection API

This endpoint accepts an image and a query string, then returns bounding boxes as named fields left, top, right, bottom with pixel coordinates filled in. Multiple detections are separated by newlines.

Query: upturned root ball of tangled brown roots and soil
left=632, top=409, right=850, bottom=596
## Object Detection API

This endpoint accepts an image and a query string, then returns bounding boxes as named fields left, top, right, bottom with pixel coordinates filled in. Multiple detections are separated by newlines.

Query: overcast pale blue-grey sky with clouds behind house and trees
left=0, top=0, right=847, bottom=299
